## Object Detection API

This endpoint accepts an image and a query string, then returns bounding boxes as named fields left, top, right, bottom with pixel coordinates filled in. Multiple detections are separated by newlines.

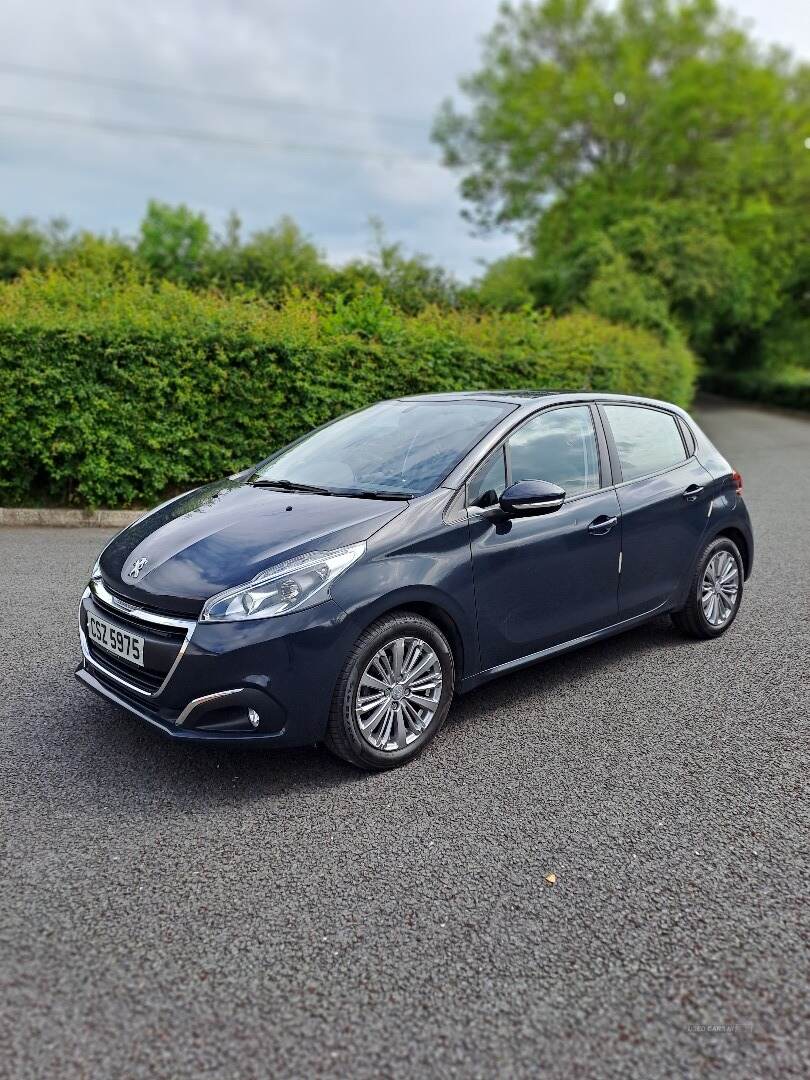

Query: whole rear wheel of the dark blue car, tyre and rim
left=672, top=537, right=743, bottom=638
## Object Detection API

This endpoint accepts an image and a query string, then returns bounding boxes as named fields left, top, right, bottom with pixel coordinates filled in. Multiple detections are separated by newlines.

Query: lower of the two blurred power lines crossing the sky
left=0, top=107, right=437, bottom=165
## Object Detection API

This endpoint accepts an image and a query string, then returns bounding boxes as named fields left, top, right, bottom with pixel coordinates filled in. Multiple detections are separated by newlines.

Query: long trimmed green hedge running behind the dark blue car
left=0, top=270, right=696, bottom=505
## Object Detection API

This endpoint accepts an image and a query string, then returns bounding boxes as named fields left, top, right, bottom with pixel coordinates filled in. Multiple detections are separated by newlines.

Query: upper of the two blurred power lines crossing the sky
left=0, top=59, right=430, bottom=131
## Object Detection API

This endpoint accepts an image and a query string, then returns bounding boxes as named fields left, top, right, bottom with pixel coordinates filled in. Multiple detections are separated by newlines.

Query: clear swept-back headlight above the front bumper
left=200, top=543, right=366, bottom=622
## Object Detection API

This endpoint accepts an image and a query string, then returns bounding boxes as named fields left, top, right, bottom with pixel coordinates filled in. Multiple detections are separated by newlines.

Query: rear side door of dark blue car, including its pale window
left=600, top=403, right=711, bottom=619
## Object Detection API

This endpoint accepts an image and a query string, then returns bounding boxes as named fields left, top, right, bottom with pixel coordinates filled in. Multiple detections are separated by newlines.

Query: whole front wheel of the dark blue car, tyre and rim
left=325, top=611, right=456, bottom=769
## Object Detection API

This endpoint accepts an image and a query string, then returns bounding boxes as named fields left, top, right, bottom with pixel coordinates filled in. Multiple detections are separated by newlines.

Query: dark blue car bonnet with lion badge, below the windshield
left=100, top=480, right=407, bottom=617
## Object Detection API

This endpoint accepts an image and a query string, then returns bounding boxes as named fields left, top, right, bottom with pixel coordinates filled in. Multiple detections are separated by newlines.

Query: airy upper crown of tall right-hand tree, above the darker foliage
left=434, top=0, right=810, bottom=226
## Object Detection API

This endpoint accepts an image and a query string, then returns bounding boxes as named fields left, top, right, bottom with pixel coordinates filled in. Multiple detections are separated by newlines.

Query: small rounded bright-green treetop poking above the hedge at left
left=137, top=199, right=211, bottom=284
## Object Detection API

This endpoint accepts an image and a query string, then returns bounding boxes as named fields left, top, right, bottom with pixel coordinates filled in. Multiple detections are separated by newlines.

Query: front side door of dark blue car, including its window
left=468, top=404, right=621, bottom=669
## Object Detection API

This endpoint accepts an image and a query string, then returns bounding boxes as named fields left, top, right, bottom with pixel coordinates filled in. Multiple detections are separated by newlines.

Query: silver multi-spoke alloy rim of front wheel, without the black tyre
left=354, top=637, right=442, bottom=751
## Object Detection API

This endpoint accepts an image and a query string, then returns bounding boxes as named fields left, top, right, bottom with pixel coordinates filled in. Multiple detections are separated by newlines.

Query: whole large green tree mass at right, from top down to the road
left=434, top=0, right=810, bottom=369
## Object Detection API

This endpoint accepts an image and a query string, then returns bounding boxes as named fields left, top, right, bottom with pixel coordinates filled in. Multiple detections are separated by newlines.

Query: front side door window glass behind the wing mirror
left=507, top=405, right=599, bottom=496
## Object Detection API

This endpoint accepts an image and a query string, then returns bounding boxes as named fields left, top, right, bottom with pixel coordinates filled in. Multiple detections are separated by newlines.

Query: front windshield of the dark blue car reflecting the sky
left=252, top=400, right=512, bottom=498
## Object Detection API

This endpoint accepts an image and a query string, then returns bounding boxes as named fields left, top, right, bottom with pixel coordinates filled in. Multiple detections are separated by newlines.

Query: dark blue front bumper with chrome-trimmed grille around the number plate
left=76, top=585, right=356, bottom=746
